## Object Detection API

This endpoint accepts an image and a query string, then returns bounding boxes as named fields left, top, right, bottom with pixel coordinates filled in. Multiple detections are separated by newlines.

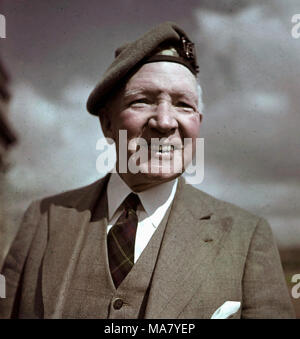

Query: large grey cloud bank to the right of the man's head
left=196, top=1, right=300, bottom=247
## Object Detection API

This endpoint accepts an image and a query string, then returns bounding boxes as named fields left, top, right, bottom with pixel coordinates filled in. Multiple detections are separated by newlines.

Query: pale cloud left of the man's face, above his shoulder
left=6, top=79, right=102, bottom=205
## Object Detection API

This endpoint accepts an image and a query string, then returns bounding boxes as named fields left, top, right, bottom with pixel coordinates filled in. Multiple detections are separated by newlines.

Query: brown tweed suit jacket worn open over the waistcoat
left=0, top=176, right=294, bottom=319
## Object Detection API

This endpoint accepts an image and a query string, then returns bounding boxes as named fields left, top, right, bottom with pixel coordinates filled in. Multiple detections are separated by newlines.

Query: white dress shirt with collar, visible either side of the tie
left=107, top=173, right=178, bottom=262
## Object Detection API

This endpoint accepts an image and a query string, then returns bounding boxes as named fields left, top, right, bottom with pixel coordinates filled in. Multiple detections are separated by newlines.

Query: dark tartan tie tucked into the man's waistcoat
left=107, top=193, right=139, bottom=288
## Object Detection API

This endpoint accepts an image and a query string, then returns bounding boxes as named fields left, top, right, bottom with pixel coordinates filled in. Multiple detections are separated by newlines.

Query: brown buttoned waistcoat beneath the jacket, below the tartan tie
left=62, top=195, right=170, bottom=319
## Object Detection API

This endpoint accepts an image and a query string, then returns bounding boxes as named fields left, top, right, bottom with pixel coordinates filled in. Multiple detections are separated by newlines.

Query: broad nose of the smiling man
left=149, top=102, right=178, bottom=133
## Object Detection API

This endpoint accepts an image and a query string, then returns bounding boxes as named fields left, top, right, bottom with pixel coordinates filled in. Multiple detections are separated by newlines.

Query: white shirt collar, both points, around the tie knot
left=107, top=173, right=178, bottom=227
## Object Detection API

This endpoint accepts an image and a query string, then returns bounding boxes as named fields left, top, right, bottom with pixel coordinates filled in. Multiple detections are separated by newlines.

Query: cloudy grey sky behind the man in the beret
left=0, top=0, right=300, bottom=248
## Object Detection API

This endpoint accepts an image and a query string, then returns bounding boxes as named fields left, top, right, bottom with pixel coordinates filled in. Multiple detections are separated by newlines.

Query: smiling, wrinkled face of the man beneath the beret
left=101, top=62, right=201, bottom=192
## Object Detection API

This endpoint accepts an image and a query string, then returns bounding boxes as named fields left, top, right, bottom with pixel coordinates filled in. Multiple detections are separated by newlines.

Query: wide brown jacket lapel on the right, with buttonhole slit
left=145, top=179, right=231, bottom=318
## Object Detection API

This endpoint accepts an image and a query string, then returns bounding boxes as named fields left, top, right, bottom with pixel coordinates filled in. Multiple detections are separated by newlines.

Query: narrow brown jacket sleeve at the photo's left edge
left=0, top=202, right=40, bottom=319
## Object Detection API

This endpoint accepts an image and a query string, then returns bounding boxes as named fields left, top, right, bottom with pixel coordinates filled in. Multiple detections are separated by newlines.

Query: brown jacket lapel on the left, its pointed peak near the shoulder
left=42, top=176, right=108, bottom=318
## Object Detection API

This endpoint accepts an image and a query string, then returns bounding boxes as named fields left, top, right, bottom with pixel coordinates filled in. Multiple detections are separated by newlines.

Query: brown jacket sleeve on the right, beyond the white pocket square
left=241, top=219, right=295, bottom=319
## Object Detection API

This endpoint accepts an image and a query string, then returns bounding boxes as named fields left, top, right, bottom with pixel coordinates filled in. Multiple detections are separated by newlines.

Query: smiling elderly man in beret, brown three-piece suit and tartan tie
left=0, top=22, right=293, bottom=319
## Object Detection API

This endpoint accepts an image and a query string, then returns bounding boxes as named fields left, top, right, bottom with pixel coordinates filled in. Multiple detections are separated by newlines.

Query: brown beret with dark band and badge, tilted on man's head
left=87, top=22, right=198, bottom=115
